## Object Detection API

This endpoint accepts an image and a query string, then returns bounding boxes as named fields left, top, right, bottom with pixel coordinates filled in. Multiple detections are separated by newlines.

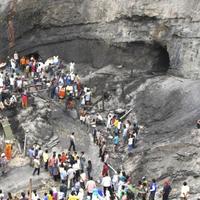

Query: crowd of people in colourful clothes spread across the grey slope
left=0, top=52, right=189, bottom=200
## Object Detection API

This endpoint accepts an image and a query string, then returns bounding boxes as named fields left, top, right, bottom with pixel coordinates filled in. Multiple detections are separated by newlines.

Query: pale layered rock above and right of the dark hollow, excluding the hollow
left=0, top=0, right=197, bottom=78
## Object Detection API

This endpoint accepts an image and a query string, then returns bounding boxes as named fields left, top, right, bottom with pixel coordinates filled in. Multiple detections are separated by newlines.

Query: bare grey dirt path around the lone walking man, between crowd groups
left=52, top=103, right=103, bottom=180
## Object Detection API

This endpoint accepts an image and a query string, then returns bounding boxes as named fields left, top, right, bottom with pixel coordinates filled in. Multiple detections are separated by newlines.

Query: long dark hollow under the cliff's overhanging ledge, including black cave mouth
left=21, top=38, right=170, bottom=73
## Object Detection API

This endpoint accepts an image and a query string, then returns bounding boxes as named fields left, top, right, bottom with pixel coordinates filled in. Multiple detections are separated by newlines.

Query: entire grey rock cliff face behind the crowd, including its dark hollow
left=0, top=0, right=200, bottom=78
